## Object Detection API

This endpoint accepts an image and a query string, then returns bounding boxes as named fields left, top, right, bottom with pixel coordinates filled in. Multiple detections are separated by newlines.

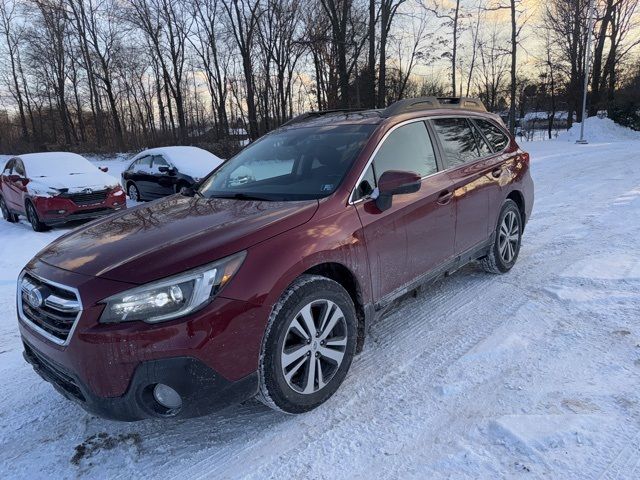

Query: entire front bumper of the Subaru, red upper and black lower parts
left=19, top=261, right=269, bottom=420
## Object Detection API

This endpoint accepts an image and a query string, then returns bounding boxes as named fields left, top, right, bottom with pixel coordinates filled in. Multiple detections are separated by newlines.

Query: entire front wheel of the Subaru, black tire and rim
left=257, top=275, right=357, bottom=414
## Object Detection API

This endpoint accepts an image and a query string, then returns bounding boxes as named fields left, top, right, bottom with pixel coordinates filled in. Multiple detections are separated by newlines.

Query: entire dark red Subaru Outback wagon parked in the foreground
left=17, top=98, right=533, bottom=420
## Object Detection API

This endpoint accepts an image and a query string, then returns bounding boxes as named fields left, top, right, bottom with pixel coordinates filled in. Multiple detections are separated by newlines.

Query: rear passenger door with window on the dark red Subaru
left=430, top=117, right=495, bottom=255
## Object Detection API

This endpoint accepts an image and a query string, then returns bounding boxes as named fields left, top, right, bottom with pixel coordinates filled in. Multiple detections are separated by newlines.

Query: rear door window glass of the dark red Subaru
left=433, top=118, right=480, bottom=168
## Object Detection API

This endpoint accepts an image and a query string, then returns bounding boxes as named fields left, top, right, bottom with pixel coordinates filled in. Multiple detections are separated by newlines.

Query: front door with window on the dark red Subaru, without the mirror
left=353, top=121, right=455, bottom=302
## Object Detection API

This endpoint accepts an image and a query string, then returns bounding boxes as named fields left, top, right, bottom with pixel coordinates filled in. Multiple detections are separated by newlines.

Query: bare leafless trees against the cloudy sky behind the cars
left=0, top=0, right=640, bottom=155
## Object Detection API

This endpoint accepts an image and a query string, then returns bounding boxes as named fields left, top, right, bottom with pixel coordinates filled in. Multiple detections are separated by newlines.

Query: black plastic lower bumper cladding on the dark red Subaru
left=23, top=342, right=258, bottom=422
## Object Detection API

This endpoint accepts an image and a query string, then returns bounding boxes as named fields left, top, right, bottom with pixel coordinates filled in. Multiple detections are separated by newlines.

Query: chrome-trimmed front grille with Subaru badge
left=18, top=272, right=82, bottom=345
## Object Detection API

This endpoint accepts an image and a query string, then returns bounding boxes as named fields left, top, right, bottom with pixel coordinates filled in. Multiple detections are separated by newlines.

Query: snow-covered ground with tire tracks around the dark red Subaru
left=0, top=134, right=640, bottom=479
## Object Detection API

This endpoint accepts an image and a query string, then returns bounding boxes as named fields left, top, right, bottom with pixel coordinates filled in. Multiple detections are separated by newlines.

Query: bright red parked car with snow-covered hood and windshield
left=0, top=152, right=127, bottom=232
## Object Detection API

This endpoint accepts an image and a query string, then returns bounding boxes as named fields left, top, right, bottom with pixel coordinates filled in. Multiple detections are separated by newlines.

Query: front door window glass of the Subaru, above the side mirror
left=373, top=122, right=438, bottom=178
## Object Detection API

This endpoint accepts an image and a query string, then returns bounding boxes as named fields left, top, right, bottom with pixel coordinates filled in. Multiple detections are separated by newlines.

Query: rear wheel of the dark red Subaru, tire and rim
left=480, top=199, right=522, bottom=273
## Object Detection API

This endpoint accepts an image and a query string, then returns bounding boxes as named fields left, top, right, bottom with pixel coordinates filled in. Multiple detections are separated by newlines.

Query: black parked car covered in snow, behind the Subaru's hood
left=122, top=147, right=223, bottom=201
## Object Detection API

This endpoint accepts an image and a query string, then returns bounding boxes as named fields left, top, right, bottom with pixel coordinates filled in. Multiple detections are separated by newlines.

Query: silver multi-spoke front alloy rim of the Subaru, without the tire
left=280, top=299, right=347, bottom=395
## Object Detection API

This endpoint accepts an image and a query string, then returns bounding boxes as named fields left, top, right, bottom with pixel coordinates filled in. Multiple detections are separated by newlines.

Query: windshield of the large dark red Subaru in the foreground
left=199, top=125, right=375, bottom=201
